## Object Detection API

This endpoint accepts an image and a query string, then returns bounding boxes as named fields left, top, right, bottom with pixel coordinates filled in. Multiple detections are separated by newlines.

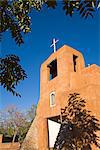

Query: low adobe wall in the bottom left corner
left=0, top=135, right=20, bottom=150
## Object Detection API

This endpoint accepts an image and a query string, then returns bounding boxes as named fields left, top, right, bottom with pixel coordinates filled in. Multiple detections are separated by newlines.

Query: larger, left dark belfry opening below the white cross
left=48, top=59, right=57, bottom=80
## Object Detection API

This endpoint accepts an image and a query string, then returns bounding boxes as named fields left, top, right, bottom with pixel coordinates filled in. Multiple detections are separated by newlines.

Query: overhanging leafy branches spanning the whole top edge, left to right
left=0, top=0, right=100, bottom=45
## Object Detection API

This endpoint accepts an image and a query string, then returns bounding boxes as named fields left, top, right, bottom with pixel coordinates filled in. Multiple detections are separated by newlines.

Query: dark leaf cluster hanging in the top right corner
left=63, top=0, right=100, bottom=19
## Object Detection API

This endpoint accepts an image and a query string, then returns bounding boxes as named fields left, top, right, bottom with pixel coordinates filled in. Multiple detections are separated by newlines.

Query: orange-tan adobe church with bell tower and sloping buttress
left=22, top=45, right=100, bottom=150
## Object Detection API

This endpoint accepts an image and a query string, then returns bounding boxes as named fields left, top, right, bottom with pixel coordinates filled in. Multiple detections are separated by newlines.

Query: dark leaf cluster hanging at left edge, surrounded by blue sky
left=0, top=55, right=27, bottom=96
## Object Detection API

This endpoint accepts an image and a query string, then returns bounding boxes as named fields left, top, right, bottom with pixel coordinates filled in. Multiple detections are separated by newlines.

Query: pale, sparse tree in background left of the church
left=0, top=106, right=31, bottom=143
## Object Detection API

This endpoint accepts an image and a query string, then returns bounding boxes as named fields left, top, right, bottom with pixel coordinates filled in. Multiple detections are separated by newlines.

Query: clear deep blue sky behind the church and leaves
left=0, top=3, right=100, bottom=111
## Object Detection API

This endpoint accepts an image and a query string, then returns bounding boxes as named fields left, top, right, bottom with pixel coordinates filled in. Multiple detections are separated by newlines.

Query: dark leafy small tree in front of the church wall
left=54, top=93, right=100, bottom=150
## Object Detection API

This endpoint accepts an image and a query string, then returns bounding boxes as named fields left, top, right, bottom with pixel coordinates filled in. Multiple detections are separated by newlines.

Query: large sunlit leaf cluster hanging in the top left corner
left=0, top=0, right=40, bottom=45
